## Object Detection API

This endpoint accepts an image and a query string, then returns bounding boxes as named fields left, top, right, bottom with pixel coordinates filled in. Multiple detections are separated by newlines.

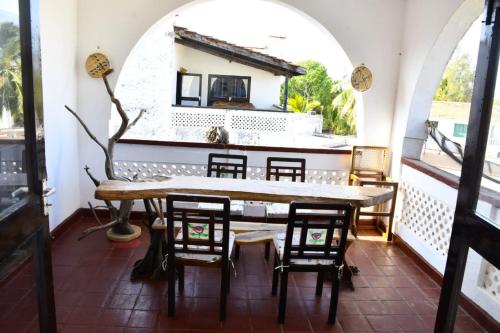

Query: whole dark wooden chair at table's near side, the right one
left=272, top=202, right=352, bottom=324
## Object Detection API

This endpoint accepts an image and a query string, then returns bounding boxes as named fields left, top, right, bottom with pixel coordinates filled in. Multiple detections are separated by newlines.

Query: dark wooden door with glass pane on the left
left=0, top=0, right=56, bottom=332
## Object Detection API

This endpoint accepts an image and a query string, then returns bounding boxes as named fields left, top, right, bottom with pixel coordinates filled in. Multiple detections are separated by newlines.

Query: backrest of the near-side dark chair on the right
left=283, top=202, right=353, bottom=266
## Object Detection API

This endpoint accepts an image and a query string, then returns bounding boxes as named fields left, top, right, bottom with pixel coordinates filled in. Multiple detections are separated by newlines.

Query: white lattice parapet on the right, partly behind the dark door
left=395, top=161, right=500, bottom=321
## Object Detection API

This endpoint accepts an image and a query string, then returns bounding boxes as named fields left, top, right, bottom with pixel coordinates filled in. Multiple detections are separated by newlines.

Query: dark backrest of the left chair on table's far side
left=207, top=153, right=247, bottom=179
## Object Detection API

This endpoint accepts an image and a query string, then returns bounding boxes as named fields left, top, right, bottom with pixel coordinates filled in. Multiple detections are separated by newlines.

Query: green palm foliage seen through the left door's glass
left=0, top=22, right=23, bottom=125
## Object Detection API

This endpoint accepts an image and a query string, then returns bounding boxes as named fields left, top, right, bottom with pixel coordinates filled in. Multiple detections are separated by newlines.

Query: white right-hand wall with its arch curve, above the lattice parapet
left=391, top=0, right=484, bottom=178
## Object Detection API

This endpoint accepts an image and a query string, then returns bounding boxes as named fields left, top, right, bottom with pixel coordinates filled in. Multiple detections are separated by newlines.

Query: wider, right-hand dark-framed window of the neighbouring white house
left=207, top=74, right=251, bottom=106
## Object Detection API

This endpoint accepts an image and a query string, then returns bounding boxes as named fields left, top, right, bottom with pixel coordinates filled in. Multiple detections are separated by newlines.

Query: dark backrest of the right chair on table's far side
left=266, top=157, right=306, bottom=182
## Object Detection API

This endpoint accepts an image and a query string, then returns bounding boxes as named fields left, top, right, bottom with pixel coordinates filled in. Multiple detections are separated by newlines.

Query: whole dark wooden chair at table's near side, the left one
left=167, top=194, right=234, bottom=320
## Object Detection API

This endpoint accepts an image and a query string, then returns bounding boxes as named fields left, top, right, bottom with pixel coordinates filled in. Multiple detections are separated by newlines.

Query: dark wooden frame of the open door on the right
left=434, top=0, right=500, bottom=333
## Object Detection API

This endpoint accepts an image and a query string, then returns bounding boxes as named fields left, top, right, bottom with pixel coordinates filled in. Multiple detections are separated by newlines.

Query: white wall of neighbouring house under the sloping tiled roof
left=173, top=43, right=281, bottom=109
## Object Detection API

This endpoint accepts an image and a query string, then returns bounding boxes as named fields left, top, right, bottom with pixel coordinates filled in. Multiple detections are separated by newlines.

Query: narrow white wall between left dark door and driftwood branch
left=40, top=0, right=81, bottom=230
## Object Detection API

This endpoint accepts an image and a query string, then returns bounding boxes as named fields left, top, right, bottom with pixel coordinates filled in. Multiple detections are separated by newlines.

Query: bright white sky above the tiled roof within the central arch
left=174, top=0, right=357, bottom=79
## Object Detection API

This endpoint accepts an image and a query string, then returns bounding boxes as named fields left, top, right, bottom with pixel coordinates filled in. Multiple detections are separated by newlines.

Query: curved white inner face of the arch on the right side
left=393, top=0, right=484, bottom=159
